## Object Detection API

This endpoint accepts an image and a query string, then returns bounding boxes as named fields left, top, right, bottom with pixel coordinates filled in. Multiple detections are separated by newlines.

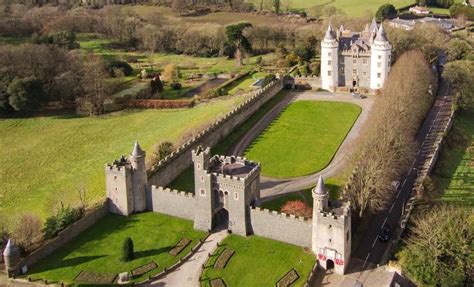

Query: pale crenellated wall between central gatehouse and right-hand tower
left=250, top=207, right=313, bottom=248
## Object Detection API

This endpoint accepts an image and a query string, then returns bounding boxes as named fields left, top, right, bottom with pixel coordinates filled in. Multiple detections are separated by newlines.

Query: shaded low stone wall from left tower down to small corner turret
left=19, top=202, right=108, bottom=267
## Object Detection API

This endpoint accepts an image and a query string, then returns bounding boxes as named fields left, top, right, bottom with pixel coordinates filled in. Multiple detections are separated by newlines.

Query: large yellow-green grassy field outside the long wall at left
left=0, top=94, right=250, bottom=221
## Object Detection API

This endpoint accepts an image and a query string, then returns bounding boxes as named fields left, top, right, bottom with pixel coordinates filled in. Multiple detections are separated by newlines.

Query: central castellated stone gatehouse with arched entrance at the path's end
left=192, top=147, right=260, bottom=236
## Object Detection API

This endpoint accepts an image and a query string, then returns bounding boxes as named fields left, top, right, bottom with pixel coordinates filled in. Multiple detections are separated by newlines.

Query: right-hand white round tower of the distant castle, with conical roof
left=370, top=24, right=392, bottom=90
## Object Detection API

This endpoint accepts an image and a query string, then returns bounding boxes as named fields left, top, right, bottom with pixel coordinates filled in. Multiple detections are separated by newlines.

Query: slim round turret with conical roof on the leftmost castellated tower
left=130, top=141, right=148, bottom=212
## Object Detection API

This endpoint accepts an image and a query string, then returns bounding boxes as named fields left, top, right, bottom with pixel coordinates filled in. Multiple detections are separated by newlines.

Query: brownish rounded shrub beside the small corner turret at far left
left=12, top=214, right=41, bottom=252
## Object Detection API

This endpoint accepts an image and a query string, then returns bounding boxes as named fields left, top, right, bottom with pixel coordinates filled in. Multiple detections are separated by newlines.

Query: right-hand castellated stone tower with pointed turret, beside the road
left=312, top=177, right=351, bottom=274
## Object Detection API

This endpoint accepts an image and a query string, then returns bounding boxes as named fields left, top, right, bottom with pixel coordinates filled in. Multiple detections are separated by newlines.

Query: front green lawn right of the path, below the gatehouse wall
left=201, top=235, right=316, bottom=287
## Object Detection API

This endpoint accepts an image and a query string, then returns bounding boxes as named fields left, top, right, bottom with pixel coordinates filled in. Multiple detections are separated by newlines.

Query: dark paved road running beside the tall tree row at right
left=352, top=79, right=452, bottom=268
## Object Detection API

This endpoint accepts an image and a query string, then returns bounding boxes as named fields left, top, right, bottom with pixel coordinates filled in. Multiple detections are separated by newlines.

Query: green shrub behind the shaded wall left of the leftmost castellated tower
left=43, top=206, right=84, bottom=239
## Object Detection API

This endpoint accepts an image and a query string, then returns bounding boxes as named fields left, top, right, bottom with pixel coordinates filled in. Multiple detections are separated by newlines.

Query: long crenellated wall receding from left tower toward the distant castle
left=148, top=78, right=284, bottom=190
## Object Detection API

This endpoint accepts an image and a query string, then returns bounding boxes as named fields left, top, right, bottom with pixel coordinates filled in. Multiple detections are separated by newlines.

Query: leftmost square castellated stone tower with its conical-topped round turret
left=105, top=142, right=148, bottom=216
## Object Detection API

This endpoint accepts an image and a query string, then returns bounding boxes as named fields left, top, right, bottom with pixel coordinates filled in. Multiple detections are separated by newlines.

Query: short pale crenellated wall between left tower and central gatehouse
left=151, top=186, right=195, bottom=221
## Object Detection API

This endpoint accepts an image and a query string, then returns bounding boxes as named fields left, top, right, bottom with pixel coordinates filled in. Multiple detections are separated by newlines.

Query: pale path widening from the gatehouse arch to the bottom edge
left=143, top=229, right=227, bottom=287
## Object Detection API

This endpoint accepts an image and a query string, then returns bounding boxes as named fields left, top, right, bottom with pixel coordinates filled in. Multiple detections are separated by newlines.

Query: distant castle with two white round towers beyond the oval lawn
left=321, top=19, right=392, bottom=91
